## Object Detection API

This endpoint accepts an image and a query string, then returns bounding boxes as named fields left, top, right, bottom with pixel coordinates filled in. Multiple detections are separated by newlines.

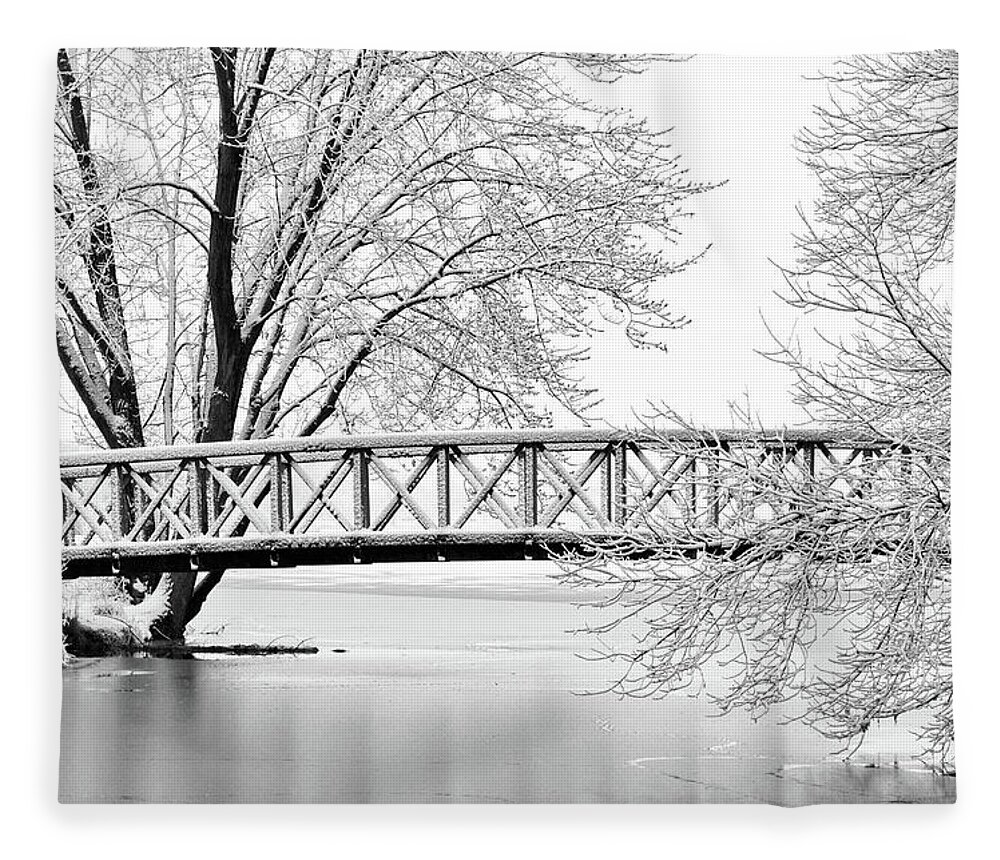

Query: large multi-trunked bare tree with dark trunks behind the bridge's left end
left=55, top=48, right=707, bottom=637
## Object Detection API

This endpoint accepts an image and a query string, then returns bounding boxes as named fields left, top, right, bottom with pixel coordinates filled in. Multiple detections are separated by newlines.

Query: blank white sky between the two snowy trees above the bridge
left=572, top=55, right=844, bottom=428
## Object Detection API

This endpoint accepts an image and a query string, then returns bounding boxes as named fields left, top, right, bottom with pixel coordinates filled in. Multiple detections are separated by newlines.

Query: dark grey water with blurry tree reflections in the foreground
left=61, top=657, right=954, bottom=804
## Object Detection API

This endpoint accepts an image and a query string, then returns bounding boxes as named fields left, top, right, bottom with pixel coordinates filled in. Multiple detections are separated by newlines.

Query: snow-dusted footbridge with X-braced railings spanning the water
left=60, top=430, right=888, bottom=579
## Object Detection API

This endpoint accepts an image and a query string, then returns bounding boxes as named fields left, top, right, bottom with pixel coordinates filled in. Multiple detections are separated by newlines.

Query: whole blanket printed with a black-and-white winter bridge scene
left=51, top=47, right=970, bottom=806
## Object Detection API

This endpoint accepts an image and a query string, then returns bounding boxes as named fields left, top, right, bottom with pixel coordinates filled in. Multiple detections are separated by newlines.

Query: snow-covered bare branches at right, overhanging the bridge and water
left=566, top=51, right=957, bottom=769
